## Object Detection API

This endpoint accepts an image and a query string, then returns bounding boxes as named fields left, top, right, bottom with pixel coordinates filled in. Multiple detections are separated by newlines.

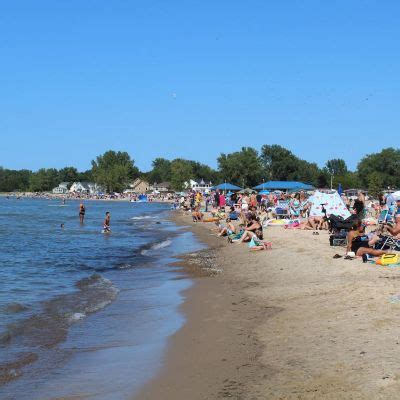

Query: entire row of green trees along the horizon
left=0, top=144, right=400, bottom=193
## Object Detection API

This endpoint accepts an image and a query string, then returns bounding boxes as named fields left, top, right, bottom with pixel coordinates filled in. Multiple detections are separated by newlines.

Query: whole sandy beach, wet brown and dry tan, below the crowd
left=135, top=214, right=400, bottom=400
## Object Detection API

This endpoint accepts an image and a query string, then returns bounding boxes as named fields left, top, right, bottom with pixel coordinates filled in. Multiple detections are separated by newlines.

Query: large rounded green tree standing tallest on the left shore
left=92, top=150, right=139, bottom=192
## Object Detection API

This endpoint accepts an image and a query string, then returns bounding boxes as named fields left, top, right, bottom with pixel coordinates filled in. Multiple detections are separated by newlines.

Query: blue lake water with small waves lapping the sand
left=0, top=198, right=200, bottom=400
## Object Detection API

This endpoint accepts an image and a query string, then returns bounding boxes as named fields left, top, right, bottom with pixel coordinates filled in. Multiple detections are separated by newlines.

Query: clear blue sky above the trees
left=0, top=0, right=400, bottom=170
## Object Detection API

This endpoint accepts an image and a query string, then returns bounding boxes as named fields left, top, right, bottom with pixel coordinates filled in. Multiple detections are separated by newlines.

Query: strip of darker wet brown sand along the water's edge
left=133, top=213, right=266, bottom=400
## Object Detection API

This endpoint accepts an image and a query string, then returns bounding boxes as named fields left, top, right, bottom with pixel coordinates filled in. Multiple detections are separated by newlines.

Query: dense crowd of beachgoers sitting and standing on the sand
left=175, top=190, right=400, bottom=262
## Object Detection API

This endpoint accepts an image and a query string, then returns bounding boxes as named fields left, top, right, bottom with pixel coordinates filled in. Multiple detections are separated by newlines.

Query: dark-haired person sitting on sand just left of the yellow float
left=347, top=220, right=387, bottom=257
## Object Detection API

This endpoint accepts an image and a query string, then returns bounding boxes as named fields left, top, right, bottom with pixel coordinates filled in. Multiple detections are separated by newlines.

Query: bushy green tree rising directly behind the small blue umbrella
left=218, top=147, right=262, bottom=187
